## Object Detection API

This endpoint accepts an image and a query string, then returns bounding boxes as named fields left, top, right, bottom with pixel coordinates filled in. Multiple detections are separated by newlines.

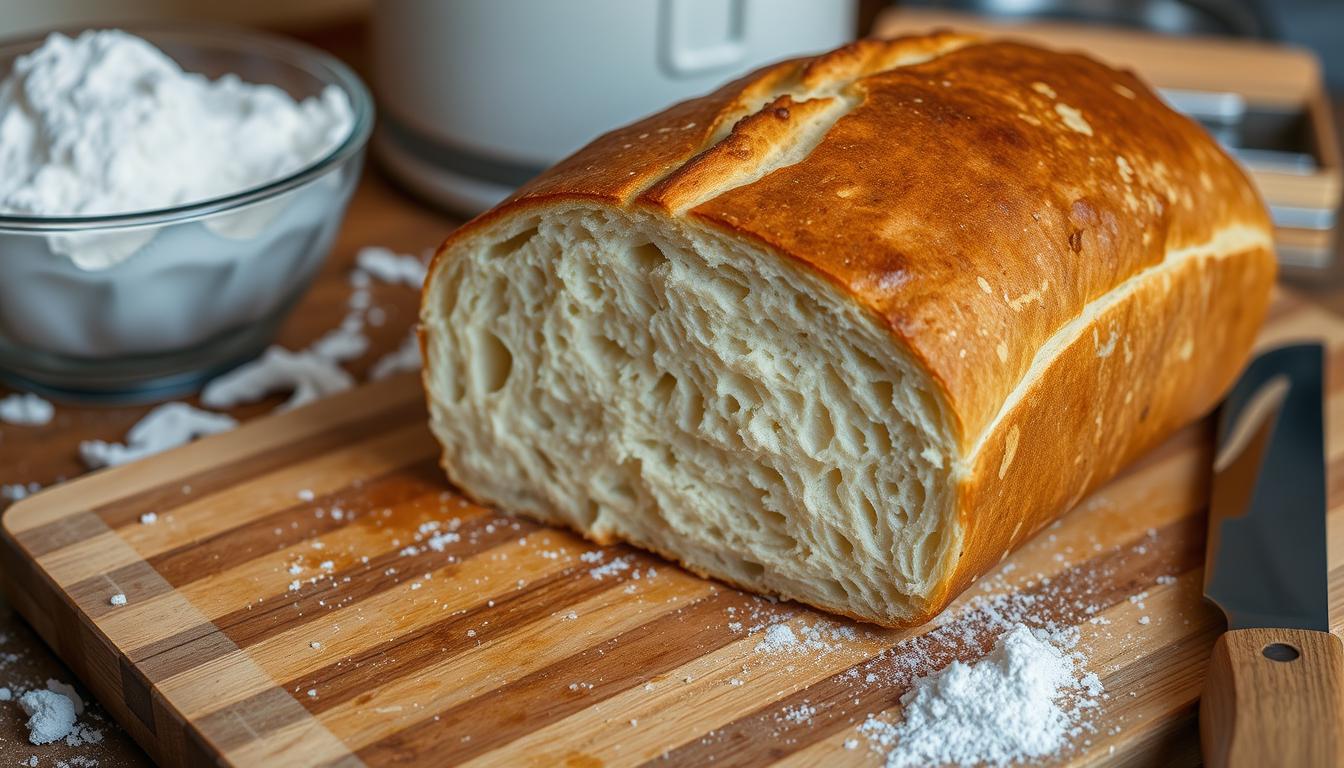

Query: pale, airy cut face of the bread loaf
left=423, top=203, right=960, bottom=623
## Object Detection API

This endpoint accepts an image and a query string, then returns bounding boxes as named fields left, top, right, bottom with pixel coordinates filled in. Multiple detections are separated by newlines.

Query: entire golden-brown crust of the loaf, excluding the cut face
left=424, top=32, right=1274, bottom=620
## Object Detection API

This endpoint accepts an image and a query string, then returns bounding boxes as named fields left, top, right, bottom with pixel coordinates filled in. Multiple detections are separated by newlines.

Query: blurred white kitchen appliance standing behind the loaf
left=374, top=0, right=856, bottom=213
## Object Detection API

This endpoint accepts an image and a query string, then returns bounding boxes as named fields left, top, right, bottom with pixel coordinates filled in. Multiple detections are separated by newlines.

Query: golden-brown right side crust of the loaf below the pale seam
left=923, top=247, right=1277, bottom=619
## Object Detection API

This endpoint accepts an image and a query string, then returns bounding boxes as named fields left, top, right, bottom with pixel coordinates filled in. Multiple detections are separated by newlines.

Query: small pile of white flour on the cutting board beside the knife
left=860, top=624, right=1102, bottom=768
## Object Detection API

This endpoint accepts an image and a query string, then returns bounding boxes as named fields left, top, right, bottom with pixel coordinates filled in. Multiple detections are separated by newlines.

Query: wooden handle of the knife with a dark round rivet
left=1199, top=629, right=1344, bottom=768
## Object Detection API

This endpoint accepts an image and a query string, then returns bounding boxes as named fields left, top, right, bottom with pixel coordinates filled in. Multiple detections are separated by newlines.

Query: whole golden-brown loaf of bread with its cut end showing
left=421, top=32, right=1275, bottom=625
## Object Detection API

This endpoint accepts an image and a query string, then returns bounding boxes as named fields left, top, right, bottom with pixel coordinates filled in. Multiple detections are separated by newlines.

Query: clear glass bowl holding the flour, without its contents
left=0, top=26, right=374, bottom=402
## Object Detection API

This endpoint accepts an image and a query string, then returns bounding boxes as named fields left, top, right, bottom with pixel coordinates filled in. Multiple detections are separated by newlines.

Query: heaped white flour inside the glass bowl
left=0, top=30, right=353, bottom=269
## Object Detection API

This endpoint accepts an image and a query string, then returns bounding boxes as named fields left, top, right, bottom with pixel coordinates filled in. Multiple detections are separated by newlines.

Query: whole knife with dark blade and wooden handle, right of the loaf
left=1199, top=344, right=1344, bottom=768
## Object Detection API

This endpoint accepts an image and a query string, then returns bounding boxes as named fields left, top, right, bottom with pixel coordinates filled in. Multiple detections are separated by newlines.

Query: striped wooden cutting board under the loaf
left=3, top=295, right=1344, bottom=767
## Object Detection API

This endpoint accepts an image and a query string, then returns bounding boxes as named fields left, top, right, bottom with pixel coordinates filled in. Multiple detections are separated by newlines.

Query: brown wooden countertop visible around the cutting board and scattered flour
left=0, top=13, right=1344, bottom=768
